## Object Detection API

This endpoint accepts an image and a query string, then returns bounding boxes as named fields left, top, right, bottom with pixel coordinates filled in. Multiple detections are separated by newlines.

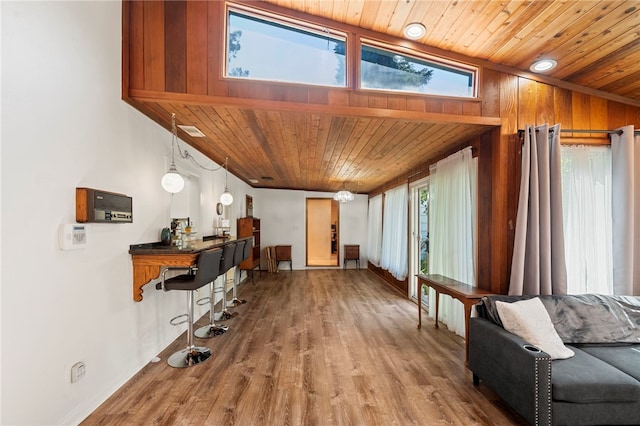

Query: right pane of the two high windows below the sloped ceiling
left=360, top=44, right=475, bottom=97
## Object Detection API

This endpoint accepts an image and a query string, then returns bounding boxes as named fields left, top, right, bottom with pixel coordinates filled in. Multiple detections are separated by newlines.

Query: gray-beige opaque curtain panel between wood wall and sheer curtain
left=509, top=124, right=567, bottom=295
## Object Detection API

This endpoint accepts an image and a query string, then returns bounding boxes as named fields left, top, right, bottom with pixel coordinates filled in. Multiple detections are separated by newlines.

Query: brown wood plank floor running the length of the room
left=82, top=269, right=525, bottom=426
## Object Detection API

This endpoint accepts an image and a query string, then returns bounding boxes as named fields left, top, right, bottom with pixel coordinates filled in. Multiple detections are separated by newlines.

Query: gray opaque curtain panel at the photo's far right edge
left=611, top=126, right=640, bottom=296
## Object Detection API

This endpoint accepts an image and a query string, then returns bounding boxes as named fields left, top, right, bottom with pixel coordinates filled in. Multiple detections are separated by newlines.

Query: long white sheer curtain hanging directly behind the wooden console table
left=429, top=148, right=477, bottom=337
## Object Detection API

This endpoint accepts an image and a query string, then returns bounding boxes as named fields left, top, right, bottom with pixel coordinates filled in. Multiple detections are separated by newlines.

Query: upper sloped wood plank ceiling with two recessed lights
left=263, top=0, right=640, bottom=101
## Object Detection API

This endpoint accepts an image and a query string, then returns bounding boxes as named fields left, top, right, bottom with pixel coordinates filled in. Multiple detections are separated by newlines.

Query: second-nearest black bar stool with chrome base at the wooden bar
left=195, top=242, right=238, bottom=339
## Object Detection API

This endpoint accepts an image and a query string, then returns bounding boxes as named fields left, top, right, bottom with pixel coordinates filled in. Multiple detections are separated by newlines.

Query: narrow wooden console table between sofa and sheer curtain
left=416, top=274, right=493, bottom=362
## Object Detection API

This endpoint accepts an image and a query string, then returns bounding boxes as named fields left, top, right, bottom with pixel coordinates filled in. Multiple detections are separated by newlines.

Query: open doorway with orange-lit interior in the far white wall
left=307, top=198, right=340, bottom=266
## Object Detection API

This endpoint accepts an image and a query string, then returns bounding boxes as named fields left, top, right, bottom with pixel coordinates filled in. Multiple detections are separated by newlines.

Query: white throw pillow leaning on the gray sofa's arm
left=496, top=297, right=575, bottom=359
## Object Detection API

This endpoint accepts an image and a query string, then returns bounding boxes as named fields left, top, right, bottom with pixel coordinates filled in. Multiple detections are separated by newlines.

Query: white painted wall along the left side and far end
left=0, top=1, right=367, bottom=425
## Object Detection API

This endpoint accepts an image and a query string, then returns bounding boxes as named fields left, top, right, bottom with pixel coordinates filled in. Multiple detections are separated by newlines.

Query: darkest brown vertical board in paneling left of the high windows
left=164, top=1, right=187, bottom=93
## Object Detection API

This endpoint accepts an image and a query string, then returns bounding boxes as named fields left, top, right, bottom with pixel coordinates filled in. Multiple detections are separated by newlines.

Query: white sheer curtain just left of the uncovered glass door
left=380, top=185, right=409, bottom=281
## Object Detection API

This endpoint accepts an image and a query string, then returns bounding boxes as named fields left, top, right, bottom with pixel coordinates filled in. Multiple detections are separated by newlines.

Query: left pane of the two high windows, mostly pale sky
left=226, top=11, right=346, bottom=87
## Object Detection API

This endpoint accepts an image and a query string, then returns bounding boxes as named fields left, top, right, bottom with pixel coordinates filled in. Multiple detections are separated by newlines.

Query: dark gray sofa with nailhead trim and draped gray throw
left=468, top=295, right=640, bottom=425
